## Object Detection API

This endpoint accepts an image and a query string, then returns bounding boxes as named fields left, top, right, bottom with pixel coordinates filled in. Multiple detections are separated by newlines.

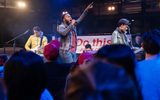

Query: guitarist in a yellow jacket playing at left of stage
left=25, top=26, right=48, bottom=54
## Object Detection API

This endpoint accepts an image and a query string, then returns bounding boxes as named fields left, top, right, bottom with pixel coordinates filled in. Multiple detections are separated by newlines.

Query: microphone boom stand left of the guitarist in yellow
left=4, top=29, right=29, bottom=53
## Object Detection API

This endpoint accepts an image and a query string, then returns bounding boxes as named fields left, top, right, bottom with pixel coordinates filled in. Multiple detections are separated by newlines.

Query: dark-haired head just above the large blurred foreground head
left=95, top=44, right=136, bottom=80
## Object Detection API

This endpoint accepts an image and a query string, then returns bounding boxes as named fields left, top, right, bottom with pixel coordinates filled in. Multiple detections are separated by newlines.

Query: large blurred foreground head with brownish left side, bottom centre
left=65, top=61, right=138, bottom=100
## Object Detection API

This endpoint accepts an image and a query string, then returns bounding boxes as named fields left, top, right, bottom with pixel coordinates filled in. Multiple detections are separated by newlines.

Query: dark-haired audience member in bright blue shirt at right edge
left=136, top=30, right=160, bottom=100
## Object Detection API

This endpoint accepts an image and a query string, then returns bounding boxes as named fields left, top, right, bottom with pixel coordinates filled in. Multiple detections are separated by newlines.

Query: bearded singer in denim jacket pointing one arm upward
left=57, top=3, right=93, bottom=63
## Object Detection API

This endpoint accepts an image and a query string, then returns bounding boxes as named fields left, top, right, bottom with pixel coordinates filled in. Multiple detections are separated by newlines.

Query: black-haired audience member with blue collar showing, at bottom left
left=4, top=51, right=53, bottom=100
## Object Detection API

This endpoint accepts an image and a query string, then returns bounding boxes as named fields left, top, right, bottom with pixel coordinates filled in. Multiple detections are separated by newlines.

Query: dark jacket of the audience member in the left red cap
left=45, top=62, right=71, bottom=100
